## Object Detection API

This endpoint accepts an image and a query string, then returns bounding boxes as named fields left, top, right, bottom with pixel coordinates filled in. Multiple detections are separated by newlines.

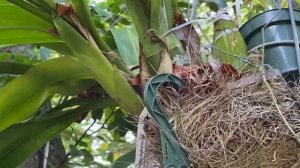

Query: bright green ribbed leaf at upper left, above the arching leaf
left=0, top=4, right=63, bottom=46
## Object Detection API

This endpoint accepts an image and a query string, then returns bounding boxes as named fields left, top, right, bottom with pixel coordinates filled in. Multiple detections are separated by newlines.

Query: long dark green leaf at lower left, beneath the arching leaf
left=0, top=97, right=115, bottom=167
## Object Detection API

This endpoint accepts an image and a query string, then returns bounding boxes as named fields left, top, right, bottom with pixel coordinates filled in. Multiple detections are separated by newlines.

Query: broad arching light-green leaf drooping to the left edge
left=0, top=57, right=91, bottom=131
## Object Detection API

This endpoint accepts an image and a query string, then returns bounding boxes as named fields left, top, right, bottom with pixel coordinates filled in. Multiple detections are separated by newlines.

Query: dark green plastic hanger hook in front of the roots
left=144, top=74, right=190, bottom=168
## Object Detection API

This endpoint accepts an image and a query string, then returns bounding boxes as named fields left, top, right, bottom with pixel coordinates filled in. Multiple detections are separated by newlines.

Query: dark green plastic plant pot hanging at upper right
left=240, top=9, right=300, bottom=79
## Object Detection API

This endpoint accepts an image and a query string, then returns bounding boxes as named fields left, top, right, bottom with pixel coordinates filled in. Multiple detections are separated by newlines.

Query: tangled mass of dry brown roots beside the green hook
left=155, top=69, right=300, bottom=168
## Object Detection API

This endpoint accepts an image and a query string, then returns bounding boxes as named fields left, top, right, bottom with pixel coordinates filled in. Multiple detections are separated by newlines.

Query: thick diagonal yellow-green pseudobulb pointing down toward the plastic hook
left=54, top=17, right=142, bottom=114
